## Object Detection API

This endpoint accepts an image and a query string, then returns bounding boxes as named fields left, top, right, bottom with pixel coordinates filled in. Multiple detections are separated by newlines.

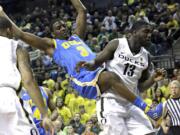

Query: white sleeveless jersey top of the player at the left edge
left=0, top=36, right=21, bottom=89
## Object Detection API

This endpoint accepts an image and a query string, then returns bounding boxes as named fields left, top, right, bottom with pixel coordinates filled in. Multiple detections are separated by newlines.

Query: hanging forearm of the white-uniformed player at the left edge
left=23, top=80, right=48, bottom=117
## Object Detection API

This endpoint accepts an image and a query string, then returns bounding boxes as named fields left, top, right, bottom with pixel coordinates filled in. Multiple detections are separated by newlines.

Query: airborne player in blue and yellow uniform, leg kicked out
left=0, top=0, right=164, bottom=120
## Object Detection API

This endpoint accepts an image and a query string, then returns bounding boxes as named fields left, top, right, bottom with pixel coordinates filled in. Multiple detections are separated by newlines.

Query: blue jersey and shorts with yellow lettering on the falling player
left=53, top=35, right=102, bottom=98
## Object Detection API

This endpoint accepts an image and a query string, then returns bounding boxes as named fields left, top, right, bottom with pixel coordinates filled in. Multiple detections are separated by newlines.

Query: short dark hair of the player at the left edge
left=0, top=16, right=12, bottom=30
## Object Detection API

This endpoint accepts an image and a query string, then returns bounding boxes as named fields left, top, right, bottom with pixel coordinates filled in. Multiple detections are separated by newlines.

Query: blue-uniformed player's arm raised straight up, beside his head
left=71, top=0, right=86, bottom=39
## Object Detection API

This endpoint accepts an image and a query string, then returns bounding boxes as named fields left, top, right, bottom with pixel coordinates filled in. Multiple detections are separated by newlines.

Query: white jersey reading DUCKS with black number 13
left=106, top=38, right=149, bottom=94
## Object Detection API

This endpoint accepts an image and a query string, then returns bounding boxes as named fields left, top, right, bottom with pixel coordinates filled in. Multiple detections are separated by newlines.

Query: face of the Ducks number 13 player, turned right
left=136, top=26, right=152, bottom=46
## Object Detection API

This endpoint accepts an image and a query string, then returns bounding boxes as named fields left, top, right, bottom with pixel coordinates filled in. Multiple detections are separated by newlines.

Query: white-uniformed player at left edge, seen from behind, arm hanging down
left=0, top=17, right=54, bottom=135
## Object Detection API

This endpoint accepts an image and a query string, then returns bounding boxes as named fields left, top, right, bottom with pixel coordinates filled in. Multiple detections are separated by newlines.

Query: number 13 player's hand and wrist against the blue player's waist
left=76, top=61, right=97, bottom=72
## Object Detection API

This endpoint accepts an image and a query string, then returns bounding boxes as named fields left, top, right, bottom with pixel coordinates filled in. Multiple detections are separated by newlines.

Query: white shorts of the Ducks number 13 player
left=96, top=97, right=154, bottom=135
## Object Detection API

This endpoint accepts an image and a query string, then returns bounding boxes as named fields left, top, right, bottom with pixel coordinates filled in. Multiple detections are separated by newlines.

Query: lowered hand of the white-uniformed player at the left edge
left=42, top=117, right=54, bottom=135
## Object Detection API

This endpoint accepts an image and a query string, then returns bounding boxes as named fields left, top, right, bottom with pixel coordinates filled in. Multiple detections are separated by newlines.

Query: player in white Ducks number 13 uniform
left=79, top=21, right=164, bottom=135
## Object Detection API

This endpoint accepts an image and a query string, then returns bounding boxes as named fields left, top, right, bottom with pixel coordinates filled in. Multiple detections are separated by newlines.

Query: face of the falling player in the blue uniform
left=53, top=21, right=68, bottom=39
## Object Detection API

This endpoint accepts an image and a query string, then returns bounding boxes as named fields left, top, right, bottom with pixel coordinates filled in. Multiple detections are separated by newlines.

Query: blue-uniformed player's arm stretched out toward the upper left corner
left=0, top=6, right=54, bottom=55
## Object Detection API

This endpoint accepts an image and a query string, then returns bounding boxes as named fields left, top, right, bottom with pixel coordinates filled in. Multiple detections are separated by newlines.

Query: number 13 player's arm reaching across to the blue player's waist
left=76, top=39, right=119, bottom=71
